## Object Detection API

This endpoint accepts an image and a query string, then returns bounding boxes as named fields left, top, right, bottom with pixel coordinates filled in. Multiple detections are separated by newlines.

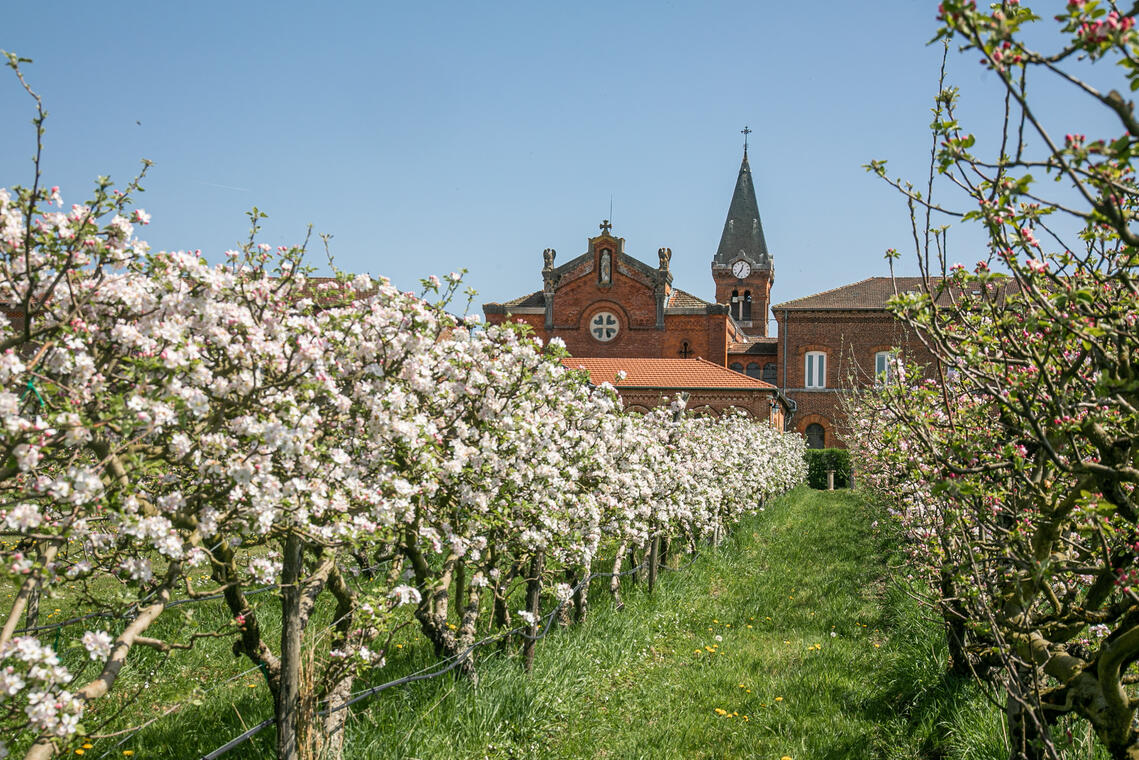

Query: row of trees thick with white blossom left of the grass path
left=0, top=57, right=803, bottom=759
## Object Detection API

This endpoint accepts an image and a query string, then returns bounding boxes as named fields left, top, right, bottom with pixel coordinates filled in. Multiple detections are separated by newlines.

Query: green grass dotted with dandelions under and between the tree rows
left=75, top=489, right=1029, bottom=760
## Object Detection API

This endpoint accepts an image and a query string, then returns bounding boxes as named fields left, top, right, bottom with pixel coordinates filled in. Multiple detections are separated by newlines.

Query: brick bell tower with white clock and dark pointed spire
left=712, top=135, right=776, bottom=337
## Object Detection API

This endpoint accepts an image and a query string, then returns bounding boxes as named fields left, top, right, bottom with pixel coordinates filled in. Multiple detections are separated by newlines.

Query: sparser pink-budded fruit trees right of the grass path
left=853, top=0, right=1139, bottom=758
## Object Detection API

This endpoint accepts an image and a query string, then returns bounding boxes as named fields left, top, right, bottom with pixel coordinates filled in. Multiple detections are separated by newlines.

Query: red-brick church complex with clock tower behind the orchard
left=483, top=145, right=920, bottom=448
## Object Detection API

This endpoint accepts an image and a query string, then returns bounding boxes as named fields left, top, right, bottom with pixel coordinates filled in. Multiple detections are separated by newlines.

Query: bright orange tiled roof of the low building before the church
left=562, top=357, right=776, bottom=391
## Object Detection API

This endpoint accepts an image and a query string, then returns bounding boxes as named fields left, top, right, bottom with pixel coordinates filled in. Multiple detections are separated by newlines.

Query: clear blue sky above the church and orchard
left=0, top=0, right=1111, bottom=321
